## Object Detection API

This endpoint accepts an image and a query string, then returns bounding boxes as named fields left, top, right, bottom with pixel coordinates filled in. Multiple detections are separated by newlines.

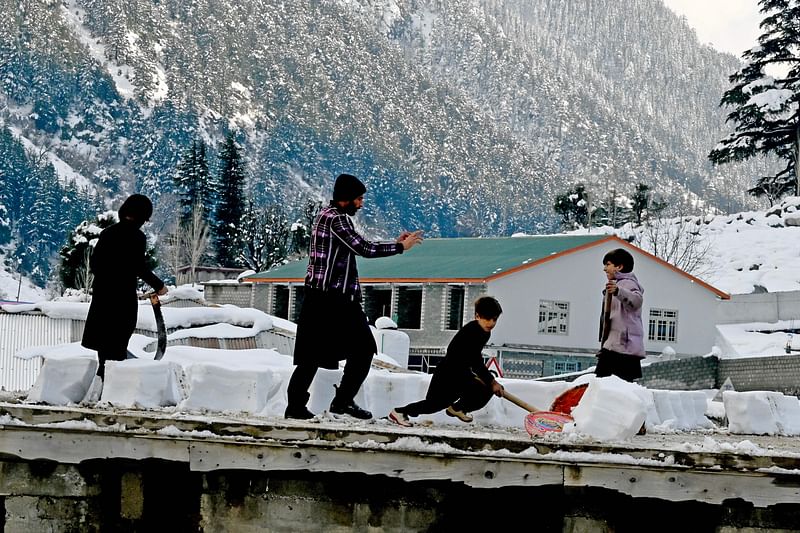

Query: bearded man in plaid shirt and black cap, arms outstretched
left=285, top=174, right=422, bottom=419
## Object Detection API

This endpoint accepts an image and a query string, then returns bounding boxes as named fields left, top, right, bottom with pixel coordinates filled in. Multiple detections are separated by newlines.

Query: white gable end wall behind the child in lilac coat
left=488, top=243, right=719, bottom=355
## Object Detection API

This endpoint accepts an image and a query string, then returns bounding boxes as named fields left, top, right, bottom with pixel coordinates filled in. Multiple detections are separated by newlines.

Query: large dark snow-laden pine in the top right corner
left=708, top=0, right=800, bottom=204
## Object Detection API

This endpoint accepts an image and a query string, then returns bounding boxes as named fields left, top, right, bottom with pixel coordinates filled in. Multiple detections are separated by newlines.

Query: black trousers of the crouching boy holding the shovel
left=396, top=374, right=492, bottom=416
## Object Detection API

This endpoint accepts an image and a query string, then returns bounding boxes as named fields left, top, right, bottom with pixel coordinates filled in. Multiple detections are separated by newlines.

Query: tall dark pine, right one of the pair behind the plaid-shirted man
left=214, top=133, right=245, bottom=267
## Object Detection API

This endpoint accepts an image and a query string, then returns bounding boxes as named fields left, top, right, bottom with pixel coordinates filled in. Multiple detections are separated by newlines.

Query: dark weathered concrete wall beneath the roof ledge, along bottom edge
left=0, top=458, right=800, bottom=533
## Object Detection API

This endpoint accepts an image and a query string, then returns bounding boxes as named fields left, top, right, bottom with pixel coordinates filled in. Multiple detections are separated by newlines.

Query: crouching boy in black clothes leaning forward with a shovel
left=389, top=296, right=503, bottom=426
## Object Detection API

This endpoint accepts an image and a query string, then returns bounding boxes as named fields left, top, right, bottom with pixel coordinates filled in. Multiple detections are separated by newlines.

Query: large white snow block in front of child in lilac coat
left=564, top=376, right=647, bottom=441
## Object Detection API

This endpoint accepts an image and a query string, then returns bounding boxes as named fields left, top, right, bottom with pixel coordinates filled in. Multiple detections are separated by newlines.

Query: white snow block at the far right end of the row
left=722, top=391, right=800, bottom=435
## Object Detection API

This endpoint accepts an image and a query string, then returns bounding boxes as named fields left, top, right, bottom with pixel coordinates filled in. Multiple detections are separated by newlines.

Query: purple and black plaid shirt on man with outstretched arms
left=305, top=205, right=403, bottom=302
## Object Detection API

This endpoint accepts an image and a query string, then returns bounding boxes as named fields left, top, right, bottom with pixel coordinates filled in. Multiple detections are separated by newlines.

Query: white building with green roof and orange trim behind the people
left=236, top=235, right=729, bottom=377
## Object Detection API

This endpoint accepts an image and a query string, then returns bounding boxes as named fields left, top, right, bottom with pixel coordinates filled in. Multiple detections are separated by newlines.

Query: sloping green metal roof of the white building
left=245, top=235, right=613, bottom=282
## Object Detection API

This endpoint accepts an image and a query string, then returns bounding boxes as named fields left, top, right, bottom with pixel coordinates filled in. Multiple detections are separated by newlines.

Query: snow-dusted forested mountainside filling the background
left=0, top=0, right=776, bottom=236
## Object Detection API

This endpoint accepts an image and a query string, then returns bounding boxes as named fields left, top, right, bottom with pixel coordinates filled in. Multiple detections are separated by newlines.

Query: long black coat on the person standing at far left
left=81, top=220, right=164, bottom=351
